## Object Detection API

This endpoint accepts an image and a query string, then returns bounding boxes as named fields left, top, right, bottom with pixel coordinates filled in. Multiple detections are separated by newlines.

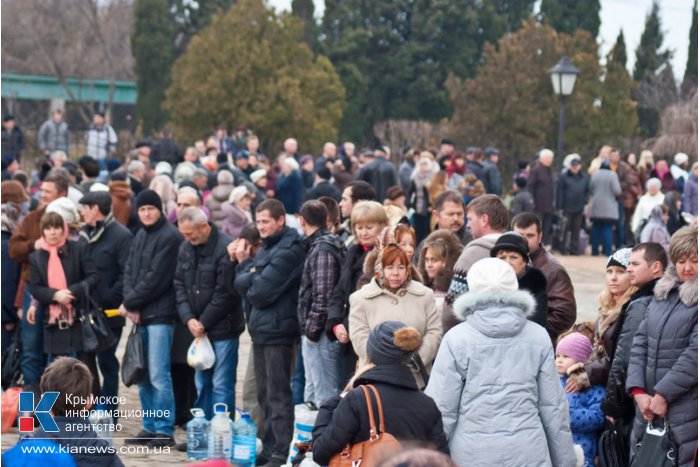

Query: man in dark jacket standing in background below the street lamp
left=556, top=158, right=590, bottom=255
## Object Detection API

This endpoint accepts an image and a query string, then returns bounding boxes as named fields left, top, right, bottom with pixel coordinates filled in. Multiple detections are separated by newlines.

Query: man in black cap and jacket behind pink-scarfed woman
left=80, top=191, right=132, bottom=420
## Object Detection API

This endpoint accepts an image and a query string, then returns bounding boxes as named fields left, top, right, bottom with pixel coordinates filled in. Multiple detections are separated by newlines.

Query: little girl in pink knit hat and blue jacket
left=556, top=332, right=605, bottom=467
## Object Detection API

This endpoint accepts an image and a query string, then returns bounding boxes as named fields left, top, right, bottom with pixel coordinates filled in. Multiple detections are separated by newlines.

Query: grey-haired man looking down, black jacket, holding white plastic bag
left=175, top=207, right=245, bottom=418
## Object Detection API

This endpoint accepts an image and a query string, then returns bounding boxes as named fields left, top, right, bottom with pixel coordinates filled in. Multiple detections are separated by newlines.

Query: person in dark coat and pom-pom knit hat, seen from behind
left=312, top=321, right=449, bottom=465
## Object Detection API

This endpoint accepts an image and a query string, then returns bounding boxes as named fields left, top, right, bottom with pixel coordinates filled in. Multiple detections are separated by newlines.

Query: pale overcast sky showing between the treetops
left=268, top=0, right=693, bottom=80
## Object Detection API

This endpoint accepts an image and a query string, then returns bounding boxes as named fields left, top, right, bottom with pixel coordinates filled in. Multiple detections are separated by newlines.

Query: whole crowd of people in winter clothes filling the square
left=2, top=116, right=697, bottom=466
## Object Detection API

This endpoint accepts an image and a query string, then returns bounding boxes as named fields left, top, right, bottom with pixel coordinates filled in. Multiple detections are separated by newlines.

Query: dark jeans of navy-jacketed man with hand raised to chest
left=253, top=344, right=294, bottom=463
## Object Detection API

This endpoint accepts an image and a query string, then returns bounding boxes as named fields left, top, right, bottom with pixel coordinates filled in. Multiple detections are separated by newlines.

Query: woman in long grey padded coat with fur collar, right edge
left=627, top=225, right=698, bottom=467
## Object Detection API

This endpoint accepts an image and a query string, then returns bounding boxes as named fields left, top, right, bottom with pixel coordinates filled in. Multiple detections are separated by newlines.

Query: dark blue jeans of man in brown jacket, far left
left=20, top=287, right=44, bottom=388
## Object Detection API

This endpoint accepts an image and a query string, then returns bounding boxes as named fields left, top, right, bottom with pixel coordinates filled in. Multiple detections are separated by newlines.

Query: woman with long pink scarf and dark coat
left=27, top=212, right=99, bottom=394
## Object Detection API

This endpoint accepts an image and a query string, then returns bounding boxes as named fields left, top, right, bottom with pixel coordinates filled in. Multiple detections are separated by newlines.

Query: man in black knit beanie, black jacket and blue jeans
left=119, top=190, right=182, bottom=447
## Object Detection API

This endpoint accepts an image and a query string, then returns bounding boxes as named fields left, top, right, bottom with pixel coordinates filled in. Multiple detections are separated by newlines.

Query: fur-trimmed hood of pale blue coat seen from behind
left=453, top=290, right=536, bottom=337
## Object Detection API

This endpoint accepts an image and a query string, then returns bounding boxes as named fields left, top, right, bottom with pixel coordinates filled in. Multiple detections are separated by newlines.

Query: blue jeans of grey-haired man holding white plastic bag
left=194, top=338, right=238, bottom=419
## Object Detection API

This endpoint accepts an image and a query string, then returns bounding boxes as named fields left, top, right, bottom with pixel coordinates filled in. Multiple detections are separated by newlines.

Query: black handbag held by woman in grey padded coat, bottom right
left=630, top=418, right=678, bottom=467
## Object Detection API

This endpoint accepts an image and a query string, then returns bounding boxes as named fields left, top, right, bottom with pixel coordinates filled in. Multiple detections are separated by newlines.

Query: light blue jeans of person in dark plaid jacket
left=301, top=333, right=340, bottom=407
